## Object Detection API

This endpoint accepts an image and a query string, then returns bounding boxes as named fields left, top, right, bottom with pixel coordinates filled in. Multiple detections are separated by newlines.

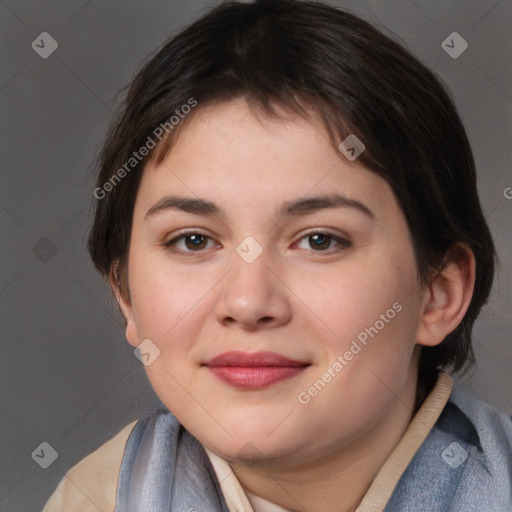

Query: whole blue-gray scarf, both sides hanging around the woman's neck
left=115, top=382, right=512, bottom=512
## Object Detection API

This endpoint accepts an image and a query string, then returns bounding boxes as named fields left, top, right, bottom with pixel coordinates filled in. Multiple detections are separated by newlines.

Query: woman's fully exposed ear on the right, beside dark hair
left=416, top=242, right=476, bottom=346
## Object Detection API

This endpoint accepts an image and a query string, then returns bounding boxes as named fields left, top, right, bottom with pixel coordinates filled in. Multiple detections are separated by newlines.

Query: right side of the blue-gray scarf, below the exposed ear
left=385, top=381, right=512, bottom=512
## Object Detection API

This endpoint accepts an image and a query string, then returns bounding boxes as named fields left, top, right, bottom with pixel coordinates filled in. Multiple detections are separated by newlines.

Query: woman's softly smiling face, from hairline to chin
left=119, top=100, right=424, bottom=465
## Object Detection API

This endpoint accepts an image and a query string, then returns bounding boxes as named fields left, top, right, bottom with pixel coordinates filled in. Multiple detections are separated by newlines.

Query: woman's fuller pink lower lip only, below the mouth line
left=208, top=366, right=307, bottom=389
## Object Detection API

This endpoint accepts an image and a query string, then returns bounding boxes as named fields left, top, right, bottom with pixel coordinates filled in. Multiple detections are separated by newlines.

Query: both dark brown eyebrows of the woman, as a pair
left=144, top=194, right=375, bottom=219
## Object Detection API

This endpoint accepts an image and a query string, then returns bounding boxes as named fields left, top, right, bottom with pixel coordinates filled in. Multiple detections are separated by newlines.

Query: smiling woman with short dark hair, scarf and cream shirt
left=45, top=0, right=512, bottom=512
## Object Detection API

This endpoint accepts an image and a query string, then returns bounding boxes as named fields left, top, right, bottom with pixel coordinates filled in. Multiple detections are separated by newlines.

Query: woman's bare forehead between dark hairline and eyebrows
left=137, top=100, right=400, bottom=224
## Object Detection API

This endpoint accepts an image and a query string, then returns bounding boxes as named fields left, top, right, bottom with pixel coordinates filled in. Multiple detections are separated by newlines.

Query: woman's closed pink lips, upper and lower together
left=205, top=351, right=309, bottom=389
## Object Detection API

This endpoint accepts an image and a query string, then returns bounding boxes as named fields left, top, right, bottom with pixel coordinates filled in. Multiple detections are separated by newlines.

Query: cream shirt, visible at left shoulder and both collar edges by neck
left=43, top=373, right=453, bottom=512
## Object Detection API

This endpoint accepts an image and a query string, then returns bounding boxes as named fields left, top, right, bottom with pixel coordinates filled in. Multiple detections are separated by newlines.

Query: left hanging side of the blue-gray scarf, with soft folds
left=115, top=404, right=229, bottom=512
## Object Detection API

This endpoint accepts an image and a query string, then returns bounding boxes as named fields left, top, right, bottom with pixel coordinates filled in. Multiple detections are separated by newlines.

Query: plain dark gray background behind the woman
left=0, top=0, right=512, bottom=512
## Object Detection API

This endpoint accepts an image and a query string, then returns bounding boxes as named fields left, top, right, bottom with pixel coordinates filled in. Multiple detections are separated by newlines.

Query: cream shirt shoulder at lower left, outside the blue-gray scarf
left=43, top=420, right=137, bottom=512
